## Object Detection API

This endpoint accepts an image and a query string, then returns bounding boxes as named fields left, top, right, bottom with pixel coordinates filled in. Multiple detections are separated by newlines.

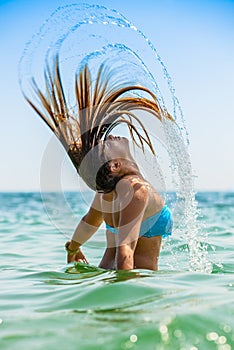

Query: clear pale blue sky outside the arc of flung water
left=0, top=0, right=234, bottom=191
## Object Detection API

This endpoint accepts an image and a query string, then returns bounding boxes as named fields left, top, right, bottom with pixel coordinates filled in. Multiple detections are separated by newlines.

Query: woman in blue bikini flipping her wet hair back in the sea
left=26, top=57, right=173, bottom=270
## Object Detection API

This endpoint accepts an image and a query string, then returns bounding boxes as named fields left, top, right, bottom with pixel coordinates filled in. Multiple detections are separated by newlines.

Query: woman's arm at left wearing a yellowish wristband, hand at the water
left=66, top=194, right=103, bottom=263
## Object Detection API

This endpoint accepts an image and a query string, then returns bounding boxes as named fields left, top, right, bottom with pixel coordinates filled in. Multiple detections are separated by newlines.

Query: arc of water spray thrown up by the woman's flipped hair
left=19, top=4, right=211, bottom=272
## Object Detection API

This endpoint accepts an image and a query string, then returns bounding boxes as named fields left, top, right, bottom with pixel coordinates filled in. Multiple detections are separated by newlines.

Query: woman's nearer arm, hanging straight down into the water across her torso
left=116, top=183, right=148, bottom=270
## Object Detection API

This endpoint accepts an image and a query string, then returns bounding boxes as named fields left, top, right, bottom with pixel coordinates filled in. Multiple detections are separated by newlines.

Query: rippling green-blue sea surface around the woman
left=0, top=192, right=234, bottom=350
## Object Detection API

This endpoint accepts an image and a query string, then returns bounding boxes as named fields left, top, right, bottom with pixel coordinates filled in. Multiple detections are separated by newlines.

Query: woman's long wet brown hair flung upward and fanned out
left=25, top=56, right=173, bottom=192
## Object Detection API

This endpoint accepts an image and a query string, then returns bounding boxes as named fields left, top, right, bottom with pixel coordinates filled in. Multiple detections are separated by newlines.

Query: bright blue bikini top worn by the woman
left=106, top=205, right=173, bottom=238
